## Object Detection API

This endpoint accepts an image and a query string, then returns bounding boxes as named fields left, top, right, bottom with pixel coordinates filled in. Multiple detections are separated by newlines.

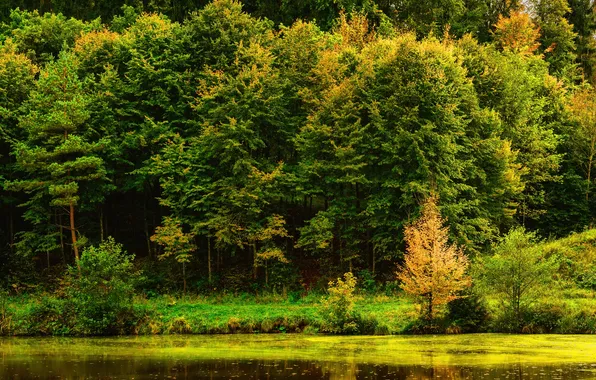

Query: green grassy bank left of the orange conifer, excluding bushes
left=0, top=296, right=417, bottom=336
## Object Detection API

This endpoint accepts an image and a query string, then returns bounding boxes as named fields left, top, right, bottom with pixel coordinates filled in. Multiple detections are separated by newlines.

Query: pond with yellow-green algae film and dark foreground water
left=0, top=334, right=596, bottom=380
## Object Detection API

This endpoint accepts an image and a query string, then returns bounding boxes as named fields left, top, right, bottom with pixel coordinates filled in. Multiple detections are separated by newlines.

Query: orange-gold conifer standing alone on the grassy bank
left=397, top=196, right=471, bottom=321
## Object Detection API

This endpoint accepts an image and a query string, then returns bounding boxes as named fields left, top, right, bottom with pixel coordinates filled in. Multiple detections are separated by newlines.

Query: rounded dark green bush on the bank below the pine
left=68, top=238, right=140, bottom=335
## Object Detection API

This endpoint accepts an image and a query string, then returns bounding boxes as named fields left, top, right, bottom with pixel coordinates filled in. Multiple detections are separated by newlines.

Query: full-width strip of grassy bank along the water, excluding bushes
left=0, top=292, right=596, bottom=336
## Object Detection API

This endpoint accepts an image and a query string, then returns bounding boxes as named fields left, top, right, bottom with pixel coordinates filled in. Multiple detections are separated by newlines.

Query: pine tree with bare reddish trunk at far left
left=9, top=54, right=106, bottom=266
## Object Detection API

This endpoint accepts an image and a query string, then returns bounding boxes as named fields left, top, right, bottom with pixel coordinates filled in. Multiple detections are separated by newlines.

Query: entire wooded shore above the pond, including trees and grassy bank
left=0, top=0, right=596, bottom=335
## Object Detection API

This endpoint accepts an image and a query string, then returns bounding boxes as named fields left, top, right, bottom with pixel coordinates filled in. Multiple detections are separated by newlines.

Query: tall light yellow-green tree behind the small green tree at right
left=458, top=38, right=569, bottom=226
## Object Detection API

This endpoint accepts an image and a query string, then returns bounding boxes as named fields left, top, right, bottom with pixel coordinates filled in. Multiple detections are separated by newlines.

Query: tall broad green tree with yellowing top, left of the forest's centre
left=152, top=25, right=292, bottom=277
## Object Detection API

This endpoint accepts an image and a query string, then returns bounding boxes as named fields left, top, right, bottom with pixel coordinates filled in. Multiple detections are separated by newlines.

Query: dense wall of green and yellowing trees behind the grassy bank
left=0, top=0, right=596, bottom=294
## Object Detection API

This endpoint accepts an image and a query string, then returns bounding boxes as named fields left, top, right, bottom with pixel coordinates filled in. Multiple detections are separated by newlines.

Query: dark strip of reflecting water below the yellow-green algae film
left=0, top=357, right=596, bottom=380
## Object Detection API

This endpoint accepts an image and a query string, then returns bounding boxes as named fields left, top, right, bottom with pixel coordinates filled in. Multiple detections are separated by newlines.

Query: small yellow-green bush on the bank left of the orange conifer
left=319, top=272, right=359, bottom=334
